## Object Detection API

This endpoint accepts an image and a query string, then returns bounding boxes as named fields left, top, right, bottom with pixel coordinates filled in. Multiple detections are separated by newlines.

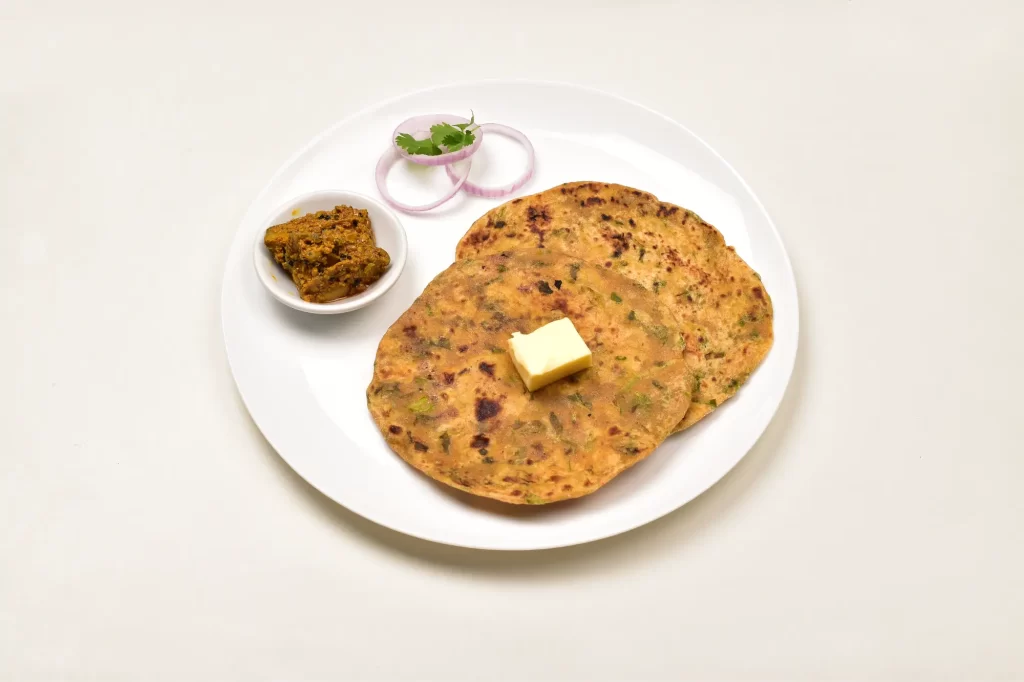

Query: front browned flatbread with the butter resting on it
left=367, top=249, right=693, bottom=504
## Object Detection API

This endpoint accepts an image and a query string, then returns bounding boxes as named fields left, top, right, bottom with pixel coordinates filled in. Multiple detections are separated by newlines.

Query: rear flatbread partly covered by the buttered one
left=457, top=182, right=773, bottom=430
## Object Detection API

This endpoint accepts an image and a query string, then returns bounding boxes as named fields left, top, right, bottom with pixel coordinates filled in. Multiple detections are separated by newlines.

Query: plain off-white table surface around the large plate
left=0, top=0, right=1024, bottom=682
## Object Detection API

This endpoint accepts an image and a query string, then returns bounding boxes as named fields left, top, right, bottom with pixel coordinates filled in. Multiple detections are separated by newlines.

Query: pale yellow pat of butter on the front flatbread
left=509, top=317, right=594, bottom=391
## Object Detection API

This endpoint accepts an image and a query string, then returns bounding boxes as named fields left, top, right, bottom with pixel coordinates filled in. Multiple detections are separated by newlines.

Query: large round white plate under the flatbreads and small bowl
left=221, top=82, right=799, bottom=550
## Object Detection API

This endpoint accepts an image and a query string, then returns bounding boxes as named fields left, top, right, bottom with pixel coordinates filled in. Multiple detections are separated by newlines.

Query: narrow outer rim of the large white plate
left=220, top=78, right=800, bottom=552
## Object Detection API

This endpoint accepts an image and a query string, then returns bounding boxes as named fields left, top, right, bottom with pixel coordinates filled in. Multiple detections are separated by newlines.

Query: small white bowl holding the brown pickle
left=253, top=189, right=409, bottom=315
